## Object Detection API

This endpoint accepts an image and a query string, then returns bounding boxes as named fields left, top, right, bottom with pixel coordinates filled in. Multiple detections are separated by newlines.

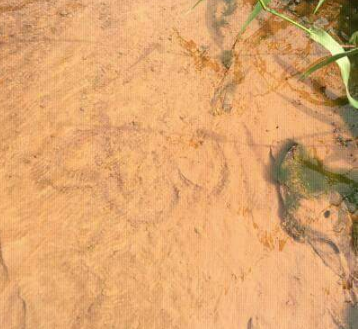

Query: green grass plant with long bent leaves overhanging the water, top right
left=191, top=0, right=358, bottom=109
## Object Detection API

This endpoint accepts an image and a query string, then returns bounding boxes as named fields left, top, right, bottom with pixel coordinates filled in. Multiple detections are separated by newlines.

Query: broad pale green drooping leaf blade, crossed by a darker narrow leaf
left=309, top=28, right=358, bottom=109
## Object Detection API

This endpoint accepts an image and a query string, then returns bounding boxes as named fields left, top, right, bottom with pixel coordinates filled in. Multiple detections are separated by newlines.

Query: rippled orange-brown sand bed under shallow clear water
left=0, top=0, right=358, bottom=329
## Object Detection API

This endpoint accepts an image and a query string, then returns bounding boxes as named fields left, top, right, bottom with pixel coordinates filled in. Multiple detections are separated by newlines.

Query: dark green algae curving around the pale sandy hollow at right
left=273, top=141, right=358, bottom=245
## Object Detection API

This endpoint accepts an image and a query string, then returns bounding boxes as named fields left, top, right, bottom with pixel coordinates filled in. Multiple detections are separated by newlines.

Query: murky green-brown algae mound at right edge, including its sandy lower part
left=271, top=141, right=358, bottom=308
